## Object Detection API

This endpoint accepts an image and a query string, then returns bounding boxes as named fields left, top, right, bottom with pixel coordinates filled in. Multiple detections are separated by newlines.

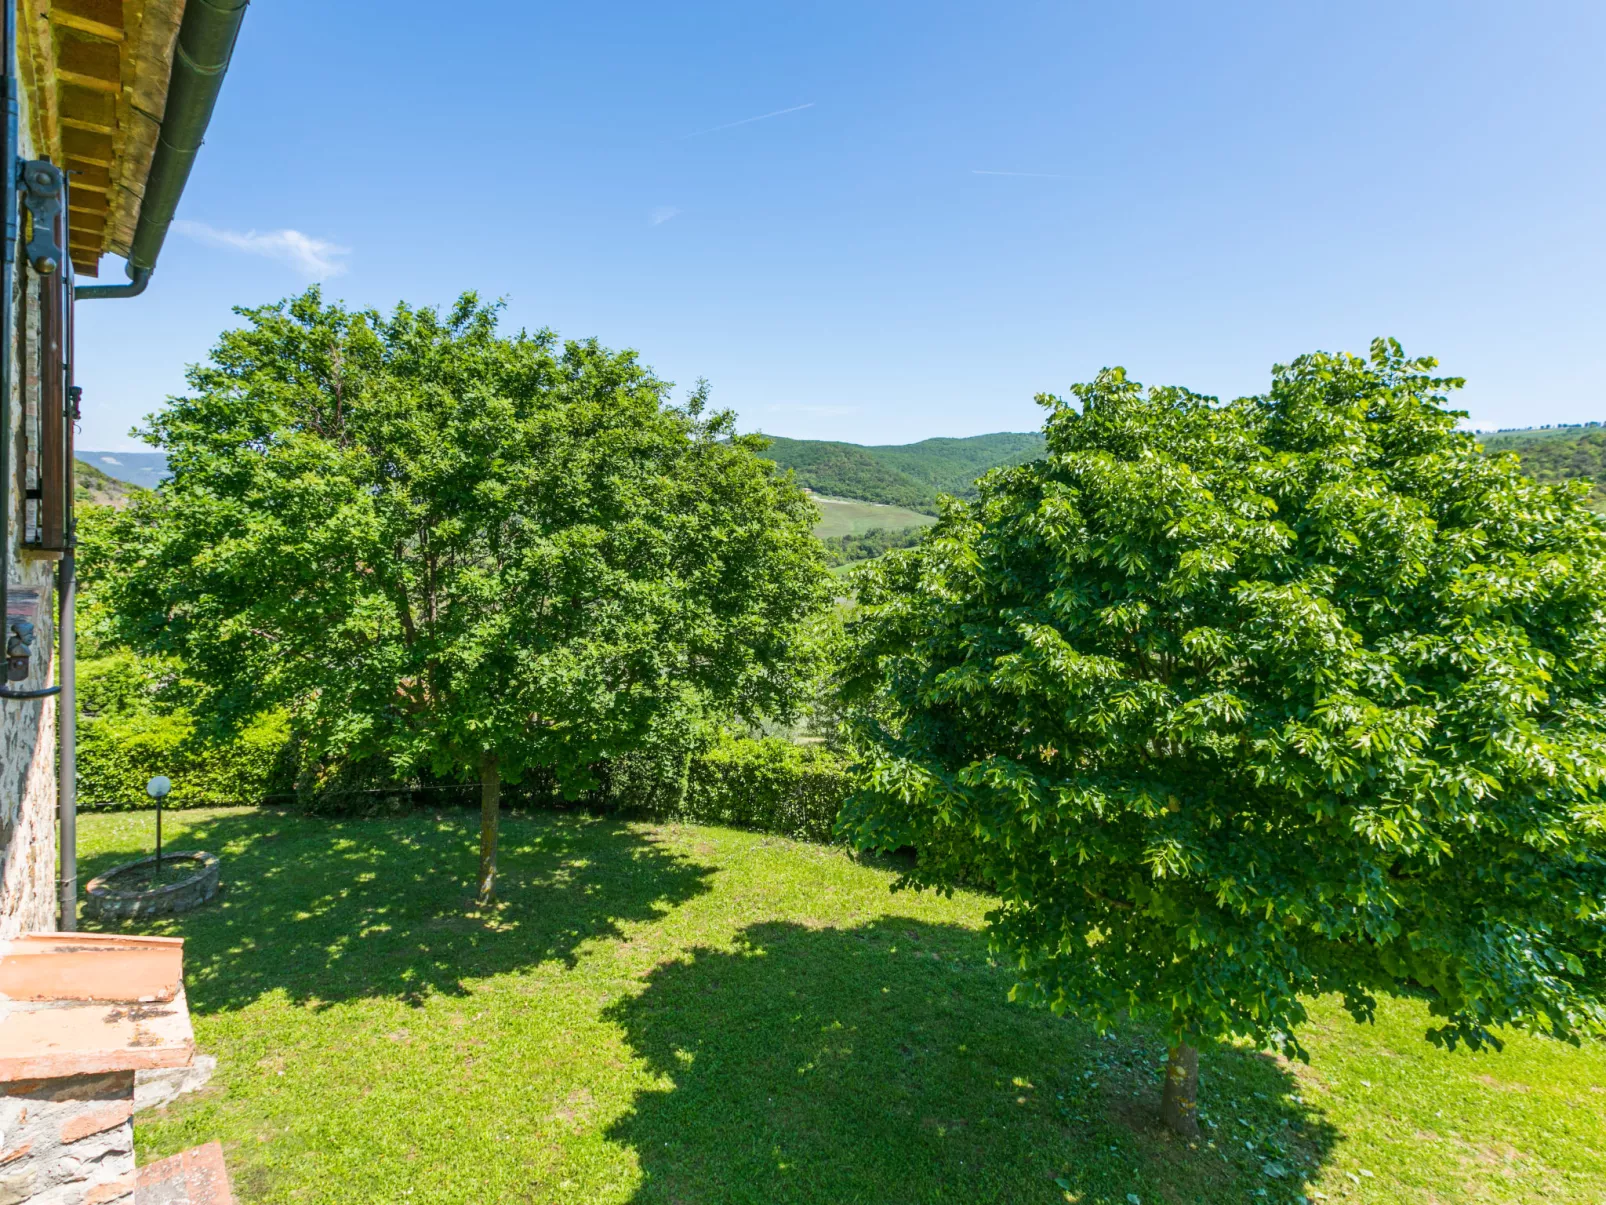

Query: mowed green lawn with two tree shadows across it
left=79, top=810, right=1606, bottom=1205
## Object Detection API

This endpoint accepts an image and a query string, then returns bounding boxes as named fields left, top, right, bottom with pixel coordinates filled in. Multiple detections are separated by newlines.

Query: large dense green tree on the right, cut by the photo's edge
left=843, top=341, right=1606, bottom=1133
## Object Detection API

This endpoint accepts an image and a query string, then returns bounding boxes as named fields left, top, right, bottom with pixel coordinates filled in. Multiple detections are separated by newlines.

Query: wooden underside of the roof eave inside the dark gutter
left=18, top=0, right=185, bottom=276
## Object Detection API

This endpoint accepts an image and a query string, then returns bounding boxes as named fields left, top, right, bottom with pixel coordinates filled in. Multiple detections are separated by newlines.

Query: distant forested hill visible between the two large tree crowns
left=764, top=431, right=1042, bottom=514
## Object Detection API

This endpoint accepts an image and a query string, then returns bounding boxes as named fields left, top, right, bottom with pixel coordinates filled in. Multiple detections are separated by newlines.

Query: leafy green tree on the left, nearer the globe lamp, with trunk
left=92, top=289, right=829, bottom=898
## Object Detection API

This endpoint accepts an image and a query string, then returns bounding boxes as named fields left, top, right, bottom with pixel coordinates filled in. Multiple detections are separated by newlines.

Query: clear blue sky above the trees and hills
left=79, top=0, right=1606, bottom=448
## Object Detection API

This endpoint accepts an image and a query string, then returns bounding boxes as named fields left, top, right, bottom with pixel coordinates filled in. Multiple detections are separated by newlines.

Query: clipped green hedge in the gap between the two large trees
left=607, top=737, right=848, bottom=842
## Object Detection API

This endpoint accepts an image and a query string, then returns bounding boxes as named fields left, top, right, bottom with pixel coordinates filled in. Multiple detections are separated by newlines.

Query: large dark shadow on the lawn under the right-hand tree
left=609, top=917, right=1335, bottom=1205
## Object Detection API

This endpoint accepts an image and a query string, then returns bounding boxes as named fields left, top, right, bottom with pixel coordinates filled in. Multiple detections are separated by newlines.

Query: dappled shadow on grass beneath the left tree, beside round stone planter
left=82, top=810, right=713, bottom=1012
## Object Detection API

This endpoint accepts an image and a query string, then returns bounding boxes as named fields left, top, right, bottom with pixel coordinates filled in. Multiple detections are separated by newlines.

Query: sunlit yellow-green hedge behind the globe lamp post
left=77, top=652, right=289, bottom=807
